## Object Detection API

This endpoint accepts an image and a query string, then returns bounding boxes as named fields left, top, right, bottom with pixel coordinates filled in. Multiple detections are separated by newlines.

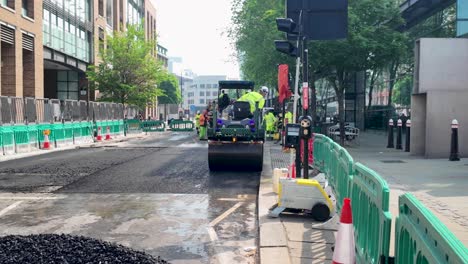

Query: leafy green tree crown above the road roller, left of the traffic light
left=229, top=0, right=293, bottom=87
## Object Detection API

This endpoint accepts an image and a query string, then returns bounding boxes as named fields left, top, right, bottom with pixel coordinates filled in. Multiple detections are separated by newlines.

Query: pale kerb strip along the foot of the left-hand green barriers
left=0, top=133, right=148, bottom=162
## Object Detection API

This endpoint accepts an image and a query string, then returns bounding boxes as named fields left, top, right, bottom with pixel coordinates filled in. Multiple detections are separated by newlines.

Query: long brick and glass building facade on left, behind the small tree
left=0, top=0, right=159, bottom=104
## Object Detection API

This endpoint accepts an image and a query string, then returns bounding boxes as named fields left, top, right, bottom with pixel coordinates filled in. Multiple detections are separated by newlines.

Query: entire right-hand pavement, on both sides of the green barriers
left=258, top=132, right=468, bottom=264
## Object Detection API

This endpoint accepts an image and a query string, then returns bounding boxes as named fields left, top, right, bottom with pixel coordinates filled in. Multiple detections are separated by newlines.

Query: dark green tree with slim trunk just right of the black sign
left=309, top=0, right=406, bottom=145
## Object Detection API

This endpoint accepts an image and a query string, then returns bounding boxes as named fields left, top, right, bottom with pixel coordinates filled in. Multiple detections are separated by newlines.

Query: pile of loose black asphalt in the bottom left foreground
left=0, top=234, right=169, bottom=264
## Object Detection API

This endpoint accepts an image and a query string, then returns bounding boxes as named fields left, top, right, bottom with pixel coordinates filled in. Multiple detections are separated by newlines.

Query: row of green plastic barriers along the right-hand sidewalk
left=314, top=134, right=468, bottom=264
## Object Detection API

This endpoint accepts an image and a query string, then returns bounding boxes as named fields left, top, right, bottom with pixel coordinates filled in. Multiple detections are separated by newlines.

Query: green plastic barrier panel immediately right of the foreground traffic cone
left=351, top=163, right=392, bottom=263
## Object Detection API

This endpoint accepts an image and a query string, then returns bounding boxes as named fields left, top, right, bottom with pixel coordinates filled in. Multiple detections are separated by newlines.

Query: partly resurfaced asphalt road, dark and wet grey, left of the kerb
left=0, top=132, right=260, bottom=263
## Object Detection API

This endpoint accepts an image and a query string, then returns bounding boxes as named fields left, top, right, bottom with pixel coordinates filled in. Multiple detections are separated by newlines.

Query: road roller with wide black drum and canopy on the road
left=207, top=81, right=265, bottom=171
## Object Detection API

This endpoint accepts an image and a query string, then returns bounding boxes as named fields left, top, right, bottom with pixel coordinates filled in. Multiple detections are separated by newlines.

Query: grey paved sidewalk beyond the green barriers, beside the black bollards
left=347, top=132, right=468, bottom=250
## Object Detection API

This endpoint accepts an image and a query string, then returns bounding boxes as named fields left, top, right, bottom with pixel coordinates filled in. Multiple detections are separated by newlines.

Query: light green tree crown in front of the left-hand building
left=86, top=25, right=165, bottom=108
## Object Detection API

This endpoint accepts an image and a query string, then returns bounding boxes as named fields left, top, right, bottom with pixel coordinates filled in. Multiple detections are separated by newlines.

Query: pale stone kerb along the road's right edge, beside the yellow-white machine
left=258, top=144, right=291, bottom=264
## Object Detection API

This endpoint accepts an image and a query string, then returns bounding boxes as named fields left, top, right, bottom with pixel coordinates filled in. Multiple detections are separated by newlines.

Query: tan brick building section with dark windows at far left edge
left=0, top=0, right=44, bottom=97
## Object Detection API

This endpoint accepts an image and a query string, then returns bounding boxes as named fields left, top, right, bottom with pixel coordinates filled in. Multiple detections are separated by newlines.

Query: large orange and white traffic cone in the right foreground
left=333, top=198, right=356, bottom=264
